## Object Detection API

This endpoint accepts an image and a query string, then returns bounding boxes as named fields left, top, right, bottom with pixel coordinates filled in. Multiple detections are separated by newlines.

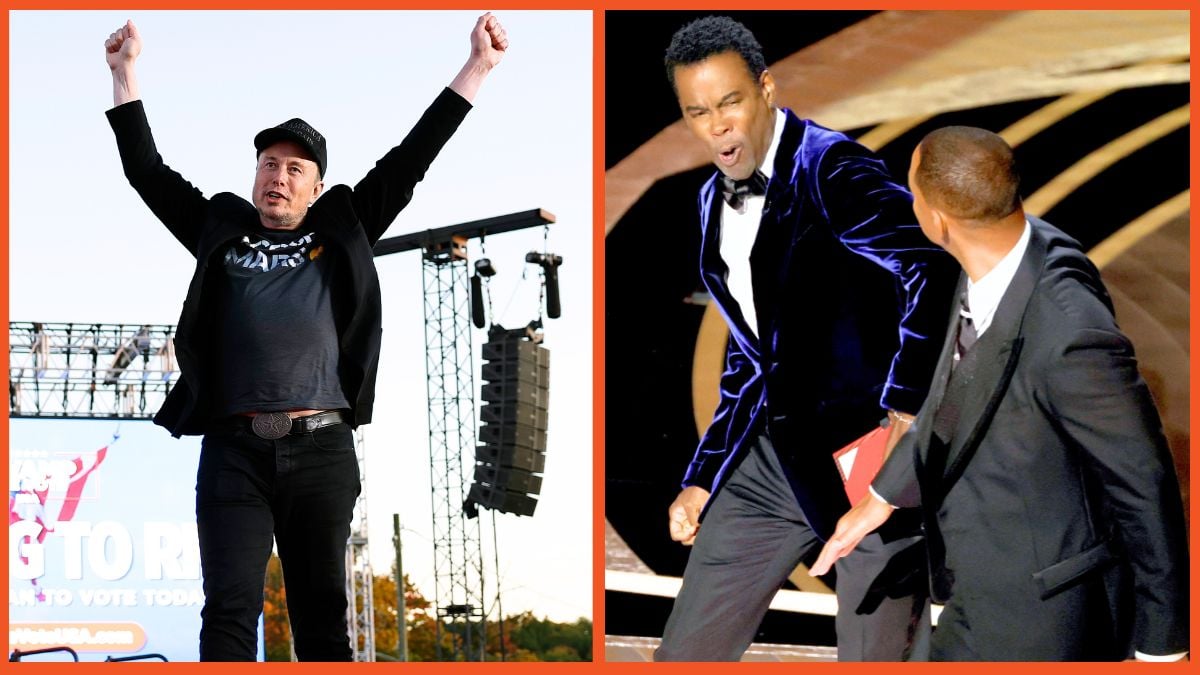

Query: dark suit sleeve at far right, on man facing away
left=1045, top=328, right=1188, bottom=655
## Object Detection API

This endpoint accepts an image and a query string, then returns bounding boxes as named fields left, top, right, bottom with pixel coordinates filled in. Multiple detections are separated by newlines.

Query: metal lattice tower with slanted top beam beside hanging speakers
left=374, top=209, right=554, bottom=661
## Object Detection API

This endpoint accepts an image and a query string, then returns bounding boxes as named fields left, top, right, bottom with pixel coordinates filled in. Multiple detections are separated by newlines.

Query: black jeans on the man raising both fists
left=196, top=423, right=361, bottom=661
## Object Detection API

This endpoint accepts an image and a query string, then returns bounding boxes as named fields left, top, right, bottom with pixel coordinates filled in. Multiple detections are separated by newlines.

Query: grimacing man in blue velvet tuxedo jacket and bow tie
left=655, top=17, right=954, bottom=661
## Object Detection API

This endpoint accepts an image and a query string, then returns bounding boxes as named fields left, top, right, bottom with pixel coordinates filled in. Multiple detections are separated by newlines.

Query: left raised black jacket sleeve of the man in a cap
left=104, top=100, right=209, bottom=256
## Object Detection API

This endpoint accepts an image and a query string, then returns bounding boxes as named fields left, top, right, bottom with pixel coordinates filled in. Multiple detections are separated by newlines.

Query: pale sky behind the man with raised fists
left=10, top=11, right=593, bottom=621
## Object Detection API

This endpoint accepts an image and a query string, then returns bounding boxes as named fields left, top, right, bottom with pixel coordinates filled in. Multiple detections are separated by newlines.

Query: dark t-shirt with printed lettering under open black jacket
left=217, top=229, right=349, bottom=414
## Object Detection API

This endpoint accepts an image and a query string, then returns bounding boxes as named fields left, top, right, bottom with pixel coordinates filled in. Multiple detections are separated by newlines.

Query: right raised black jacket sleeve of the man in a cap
left=353, top=88, right=472, bottom=245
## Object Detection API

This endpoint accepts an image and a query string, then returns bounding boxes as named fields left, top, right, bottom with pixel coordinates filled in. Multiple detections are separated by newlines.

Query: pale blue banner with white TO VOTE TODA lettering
left=8, top=419, right=238, bottom=661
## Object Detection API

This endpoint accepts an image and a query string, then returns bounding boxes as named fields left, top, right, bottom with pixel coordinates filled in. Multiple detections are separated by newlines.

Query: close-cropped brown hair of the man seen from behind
left=913, top=126, right=1021, bottom=220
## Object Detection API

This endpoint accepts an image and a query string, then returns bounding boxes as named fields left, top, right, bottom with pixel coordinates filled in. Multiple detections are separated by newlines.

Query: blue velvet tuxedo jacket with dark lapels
left=683, top=110, right=956, bottom=539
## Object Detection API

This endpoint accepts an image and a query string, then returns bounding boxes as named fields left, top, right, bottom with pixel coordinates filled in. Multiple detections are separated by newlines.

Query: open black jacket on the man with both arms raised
left=107, top=89, right=470, bottom=436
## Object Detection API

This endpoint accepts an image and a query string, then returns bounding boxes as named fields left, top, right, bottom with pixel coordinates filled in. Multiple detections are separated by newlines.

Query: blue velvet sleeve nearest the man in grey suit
left=814, top=141, right=959, bottom=413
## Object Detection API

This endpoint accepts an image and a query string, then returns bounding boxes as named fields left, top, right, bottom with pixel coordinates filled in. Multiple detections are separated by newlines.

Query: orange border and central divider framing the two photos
left=0, top=0, right=1200, bottom=675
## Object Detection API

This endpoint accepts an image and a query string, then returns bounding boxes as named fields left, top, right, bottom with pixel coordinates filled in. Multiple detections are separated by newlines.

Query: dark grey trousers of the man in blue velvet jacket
left=654, top=438, right=931, bottom=661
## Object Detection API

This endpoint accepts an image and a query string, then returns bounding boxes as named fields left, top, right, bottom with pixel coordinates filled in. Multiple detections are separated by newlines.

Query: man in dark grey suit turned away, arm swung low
left=812, top=127, right=1188, bottom=661
